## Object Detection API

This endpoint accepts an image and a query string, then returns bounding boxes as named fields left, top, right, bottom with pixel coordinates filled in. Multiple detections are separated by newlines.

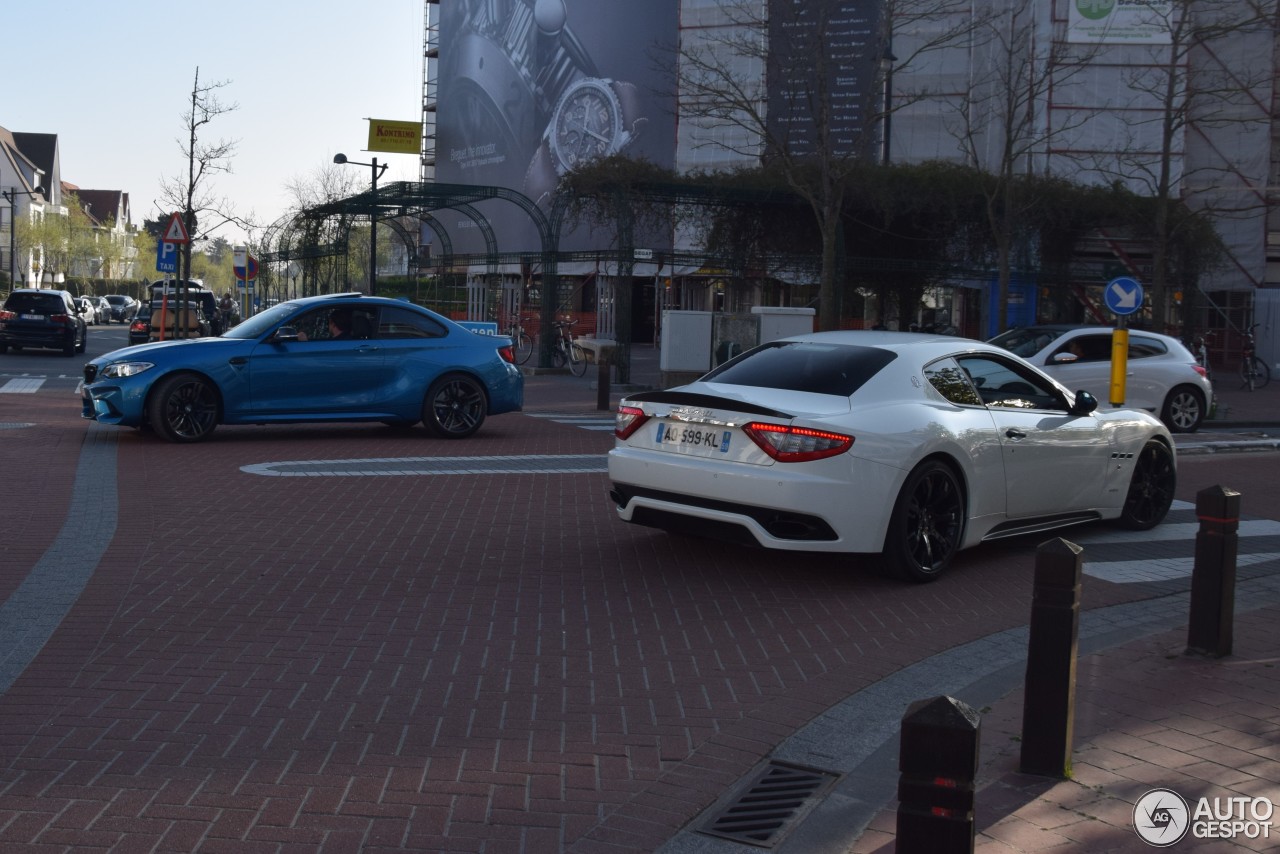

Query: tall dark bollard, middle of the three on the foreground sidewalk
left=1019, top=538, right=1084, bottom=778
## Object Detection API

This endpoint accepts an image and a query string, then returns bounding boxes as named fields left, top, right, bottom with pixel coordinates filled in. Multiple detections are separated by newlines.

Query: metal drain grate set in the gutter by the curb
left=698, top=762, right=836, bottom=848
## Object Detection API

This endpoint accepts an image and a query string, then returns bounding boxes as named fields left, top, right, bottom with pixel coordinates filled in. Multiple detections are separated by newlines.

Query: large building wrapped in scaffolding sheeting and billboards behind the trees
left=280, top=0, right=1280, bottom=364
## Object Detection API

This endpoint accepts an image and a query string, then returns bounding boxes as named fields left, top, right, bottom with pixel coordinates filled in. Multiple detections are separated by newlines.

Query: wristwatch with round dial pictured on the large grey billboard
left=525, top=77, right=646, bottom=205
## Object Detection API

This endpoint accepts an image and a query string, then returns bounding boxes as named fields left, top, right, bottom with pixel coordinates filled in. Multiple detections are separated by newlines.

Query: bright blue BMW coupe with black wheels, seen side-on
left=82, top=293, right=524, bottom=442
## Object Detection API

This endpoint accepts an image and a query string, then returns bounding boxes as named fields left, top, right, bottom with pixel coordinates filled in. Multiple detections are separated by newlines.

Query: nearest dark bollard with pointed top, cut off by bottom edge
left=896, top=697, right=982, bottom=854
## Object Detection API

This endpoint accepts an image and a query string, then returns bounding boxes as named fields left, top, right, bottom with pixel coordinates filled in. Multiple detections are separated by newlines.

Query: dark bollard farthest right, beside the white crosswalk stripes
left=1187, top=487, right=1240, bottom=658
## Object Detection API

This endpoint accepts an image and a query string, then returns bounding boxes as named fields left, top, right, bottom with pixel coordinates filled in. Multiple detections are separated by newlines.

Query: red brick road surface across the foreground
left=0, top=343, right=1275, bottom=853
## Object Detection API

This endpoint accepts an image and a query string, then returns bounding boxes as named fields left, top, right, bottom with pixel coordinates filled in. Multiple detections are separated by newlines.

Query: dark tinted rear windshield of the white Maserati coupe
left=701, top=341, right=897, bottom=397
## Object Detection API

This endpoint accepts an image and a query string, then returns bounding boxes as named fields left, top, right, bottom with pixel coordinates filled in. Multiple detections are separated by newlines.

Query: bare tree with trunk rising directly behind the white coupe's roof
left=677, top=0, right=973, bottom=329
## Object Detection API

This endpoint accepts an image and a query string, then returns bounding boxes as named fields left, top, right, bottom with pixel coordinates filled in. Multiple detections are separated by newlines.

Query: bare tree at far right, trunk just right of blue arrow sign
left=1075, top=0, right=1276, bottom=324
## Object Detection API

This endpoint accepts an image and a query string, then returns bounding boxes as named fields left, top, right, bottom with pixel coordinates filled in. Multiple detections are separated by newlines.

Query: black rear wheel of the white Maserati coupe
left=883, top=460, right=965, bottom=583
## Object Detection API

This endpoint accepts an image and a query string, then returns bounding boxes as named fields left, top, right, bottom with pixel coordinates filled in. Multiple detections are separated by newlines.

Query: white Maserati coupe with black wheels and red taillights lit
left=608, top=332, right=1176, bottom=581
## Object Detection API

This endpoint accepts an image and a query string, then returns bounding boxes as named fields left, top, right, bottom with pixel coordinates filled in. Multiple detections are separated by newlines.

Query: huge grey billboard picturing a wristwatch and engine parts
left=436, top=0, right=680, bottom=252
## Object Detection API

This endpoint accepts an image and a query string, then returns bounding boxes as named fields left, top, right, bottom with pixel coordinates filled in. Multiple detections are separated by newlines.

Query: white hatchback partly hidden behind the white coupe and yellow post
left=991, top=324, right=1213, bottom=433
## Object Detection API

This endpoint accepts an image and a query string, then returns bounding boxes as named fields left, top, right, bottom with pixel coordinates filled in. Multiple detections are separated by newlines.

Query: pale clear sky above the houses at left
left=0, top=0, right=424, bottom=243
